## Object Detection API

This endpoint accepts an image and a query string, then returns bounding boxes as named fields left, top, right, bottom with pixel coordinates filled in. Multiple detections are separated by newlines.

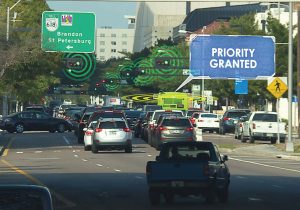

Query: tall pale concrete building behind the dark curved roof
left=133, top=1, right=245, bottom=52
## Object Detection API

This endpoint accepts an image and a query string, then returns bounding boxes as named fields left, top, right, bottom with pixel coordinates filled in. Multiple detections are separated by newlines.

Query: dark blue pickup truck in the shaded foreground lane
left=146, top=142, right=230, bottom=205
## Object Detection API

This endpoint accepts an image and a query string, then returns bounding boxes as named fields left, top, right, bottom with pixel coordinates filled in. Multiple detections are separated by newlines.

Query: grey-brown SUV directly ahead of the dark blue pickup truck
left=152, top=116, right=197, bottom=150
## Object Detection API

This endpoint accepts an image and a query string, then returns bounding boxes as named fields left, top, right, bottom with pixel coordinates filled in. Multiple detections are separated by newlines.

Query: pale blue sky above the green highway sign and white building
left=46, top=0, right=136, bottom=28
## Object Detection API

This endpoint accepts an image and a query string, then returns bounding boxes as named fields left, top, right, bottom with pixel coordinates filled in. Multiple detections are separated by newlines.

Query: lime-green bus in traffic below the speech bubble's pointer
left=157, top=92, right=190, bottom=111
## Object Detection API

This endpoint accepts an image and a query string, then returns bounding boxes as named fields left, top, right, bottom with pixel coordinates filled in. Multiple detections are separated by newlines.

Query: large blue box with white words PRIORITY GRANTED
left=190, top=35, right=275, bottom=79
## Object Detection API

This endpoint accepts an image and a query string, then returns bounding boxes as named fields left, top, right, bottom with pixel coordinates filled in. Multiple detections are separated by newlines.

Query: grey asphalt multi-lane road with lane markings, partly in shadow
left=0, top=132, right=300, bottom=210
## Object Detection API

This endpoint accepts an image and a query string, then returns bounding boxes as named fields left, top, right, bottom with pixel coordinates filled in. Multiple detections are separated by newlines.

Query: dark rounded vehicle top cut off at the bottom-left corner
left=0, top=185, right=53, bottom=210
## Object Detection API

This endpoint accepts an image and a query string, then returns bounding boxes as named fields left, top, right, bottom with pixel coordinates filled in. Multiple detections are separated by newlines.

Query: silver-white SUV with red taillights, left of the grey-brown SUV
left=91, top=118, right=132, bottom=153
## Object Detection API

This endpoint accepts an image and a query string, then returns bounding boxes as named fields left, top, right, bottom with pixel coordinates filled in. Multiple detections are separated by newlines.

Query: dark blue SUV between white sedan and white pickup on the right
left=219, top=109, right=251, bottom=135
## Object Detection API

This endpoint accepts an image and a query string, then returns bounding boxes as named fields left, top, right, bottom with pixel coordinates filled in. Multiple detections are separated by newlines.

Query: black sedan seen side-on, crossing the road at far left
left=0, top=111, right=71, bottom=133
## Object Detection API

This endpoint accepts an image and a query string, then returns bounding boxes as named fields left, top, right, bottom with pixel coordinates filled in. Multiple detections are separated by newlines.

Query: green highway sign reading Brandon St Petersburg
left=42, top=11, right=96, bottom=53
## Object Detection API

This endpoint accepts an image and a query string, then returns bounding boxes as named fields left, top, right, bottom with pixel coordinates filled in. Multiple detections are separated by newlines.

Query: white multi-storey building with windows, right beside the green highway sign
left=96, top=16, right=135, bottom=61
